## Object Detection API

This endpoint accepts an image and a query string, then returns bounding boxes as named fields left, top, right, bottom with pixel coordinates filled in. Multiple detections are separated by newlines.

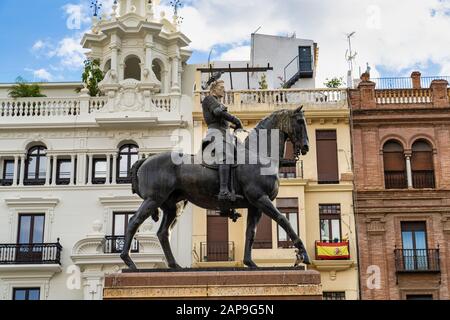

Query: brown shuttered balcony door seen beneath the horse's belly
left=206, top=211, right=229, bottom=261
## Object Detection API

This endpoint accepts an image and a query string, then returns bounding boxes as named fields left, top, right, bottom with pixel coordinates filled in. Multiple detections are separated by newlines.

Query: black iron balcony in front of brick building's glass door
left=394, top=249, right=441, bottom=273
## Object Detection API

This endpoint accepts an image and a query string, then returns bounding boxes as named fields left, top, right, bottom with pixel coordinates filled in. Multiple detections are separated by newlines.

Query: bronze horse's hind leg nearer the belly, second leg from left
left=157, top=202, right=181, bottom=269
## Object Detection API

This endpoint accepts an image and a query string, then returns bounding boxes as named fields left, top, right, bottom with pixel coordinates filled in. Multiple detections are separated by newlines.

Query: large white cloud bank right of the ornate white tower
left=175, top=0, right=450, bottom=85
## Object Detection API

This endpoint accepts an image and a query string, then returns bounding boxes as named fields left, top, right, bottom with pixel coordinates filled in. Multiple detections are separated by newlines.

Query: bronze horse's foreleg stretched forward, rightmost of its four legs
left=252, top=195, right=311, bottom=264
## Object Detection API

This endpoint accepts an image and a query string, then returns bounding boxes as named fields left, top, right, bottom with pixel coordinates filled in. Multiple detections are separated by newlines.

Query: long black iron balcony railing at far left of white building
left=0, top=239, right=62, bottom=265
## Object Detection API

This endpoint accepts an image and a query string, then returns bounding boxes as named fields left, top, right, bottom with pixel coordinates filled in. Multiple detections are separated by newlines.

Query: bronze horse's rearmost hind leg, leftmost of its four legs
left=120, top=199, right=158, bottom=270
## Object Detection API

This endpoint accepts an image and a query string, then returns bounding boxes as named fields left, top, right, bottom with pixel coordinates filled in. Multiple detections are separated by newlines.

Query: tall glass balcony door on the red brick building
left=401, top=222, right=428, bottom=271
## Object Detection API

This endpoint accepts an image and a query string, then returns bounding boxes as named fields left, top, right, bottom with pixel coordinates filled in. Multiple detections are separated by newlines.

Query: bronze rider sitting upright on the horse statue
left=202, top=80, right=243, bottom=201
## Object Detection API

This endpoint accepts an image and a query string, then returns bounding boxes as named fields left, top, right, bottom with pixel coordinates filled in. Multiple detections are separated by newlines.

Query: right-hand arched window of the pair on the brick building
left=411, top=140, right=435, bottom=189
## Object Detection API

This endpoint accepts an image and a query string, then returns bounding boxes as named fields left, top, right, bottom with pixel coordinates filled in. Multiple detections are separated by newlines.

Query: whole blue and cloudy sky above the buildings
left=0, top=0, right=450, bottom=86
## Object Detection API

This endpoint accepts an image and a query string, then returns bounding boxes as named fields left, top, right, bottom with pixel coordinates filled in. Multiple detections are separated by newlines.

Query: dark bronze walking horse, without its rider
left=120, top=107, right=310, bottom=270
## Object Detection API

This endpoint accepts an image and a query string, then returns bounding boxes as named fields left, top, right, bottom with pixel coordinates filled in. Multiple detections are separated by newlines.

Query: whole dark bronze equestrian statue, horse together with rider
left=120, top=74, right=310, bottom=269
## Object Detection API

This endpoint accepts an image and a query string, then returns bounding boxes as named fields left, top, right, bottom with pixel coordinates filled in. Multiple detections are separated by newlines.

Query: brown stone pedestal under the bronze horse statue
left=103, top=268, right=322, bottom=300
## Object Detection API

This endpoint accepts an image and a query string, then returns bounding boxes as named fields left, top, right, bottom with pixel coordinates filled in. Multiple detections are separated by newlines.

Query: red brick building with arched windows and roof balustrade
left=349, top=72, right=450, bottom=300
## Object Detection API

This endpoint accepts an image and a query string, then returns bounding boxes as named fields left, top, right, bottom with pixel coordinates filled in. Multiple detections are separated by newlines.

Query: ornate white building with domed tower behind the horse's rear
left=0, top=0, right=194, bottom=300
